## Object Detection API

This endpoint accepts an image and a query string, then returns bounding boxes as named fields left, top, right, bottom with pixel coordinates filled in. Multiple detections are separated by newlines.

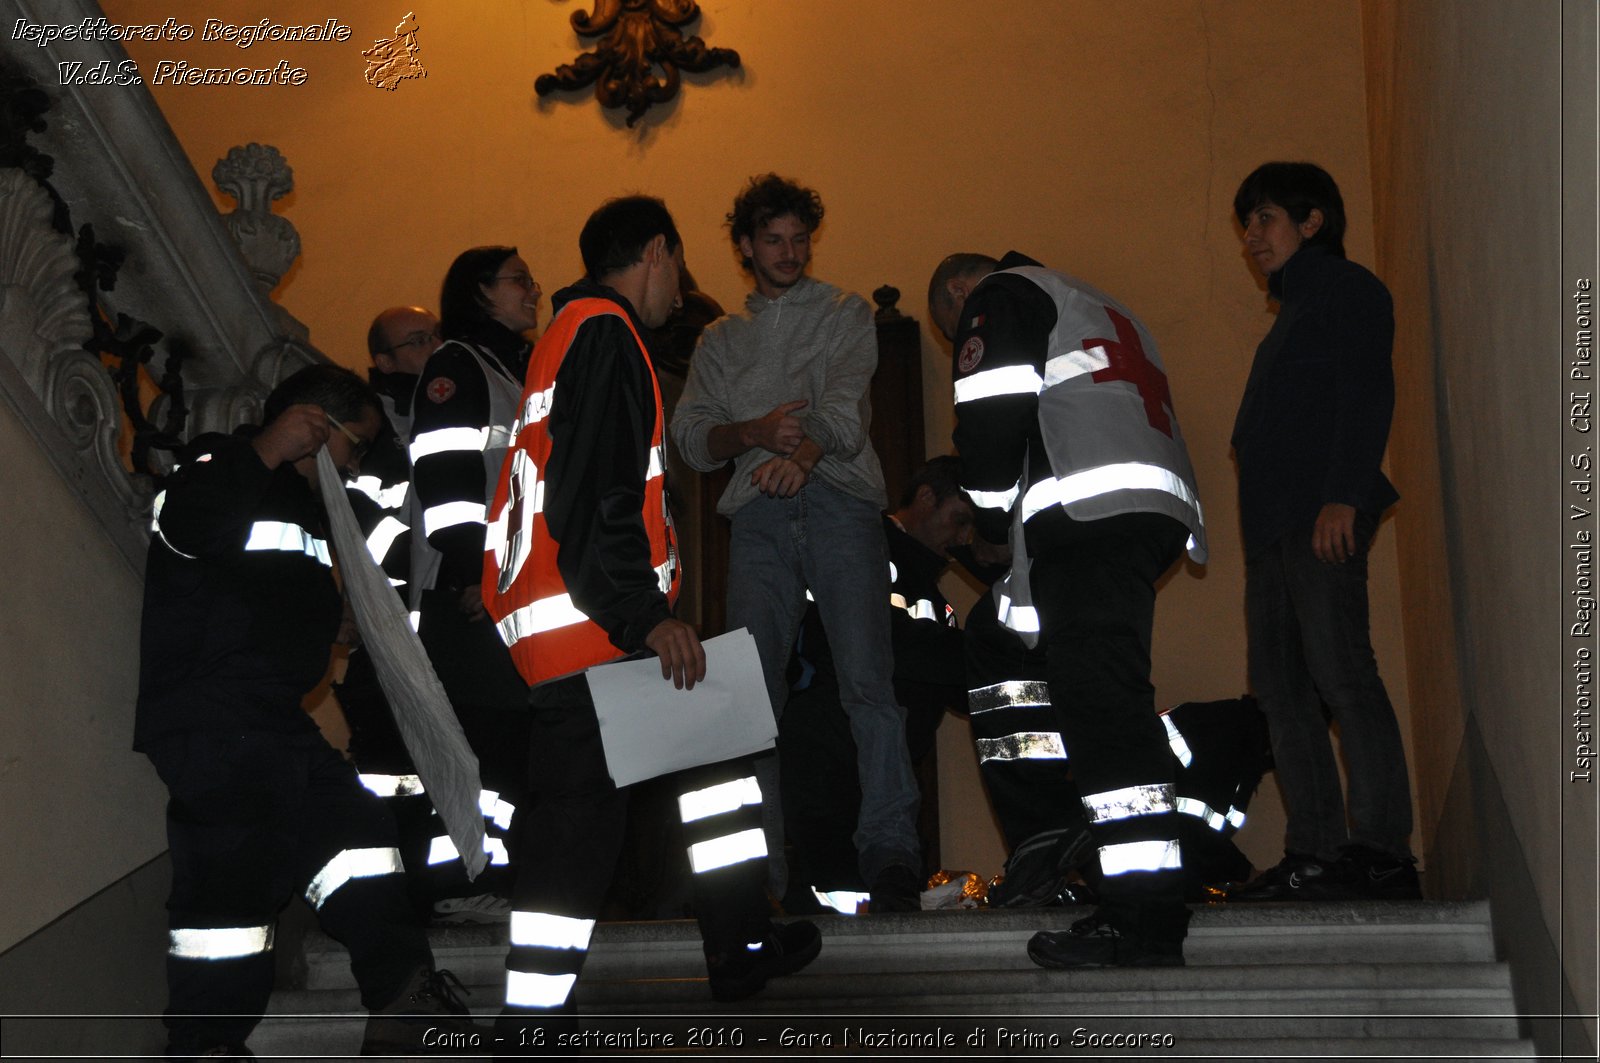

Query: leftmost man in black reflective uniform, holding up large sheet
left=134, top=365, right=474, bottom=1060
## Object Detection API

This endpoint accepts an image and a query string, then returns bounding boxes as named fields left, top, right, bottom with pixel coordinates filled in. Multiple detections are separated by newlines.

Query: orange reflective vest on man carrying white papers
left=483, top=298, right=678, bottom=685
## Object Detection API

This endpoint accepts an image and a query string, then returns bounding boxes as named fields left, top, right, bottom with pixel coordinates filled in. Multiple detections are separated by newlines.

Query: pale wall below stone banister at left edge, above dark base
left=0, top=393, right=166, bottom=951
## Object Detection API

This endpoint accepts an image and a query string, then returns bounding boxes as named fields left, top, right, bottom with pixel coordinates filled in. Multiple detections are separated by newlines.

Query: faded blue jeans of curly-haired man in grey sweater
left=728, top=480, right=922, bottom=897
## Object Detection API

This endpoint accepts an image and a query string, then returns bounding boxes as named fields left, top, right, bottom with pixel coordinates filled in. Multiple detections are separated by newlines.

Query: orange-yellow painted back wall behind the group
left=104, top=0, right=1406, bottom=872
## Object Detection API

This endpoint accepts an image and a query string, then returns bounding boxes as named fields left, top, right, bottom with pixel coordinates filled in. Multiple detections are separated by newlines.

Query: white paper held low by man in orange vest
left=586, top=628, right=778, bottom=786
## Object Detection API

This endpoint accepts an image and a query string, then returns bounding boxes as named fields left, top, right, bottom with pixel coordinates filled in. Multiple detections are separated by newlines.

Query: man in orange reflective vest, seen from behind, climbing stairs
left=483, top=195, right=821, bottom=1053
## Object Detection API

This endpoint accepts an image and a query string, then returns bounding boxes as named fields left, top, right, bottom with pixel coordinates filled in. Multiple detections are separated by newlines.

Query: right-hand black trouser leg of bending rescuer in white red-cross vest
left=1029, top=511, right=1189, bottom=941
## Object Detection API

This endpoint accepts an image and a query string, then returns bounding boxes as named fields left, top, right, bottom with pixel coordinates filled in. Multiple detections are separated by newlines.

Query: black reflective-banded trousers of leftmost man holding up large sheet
left=146, top=726, right=432, bottom=1053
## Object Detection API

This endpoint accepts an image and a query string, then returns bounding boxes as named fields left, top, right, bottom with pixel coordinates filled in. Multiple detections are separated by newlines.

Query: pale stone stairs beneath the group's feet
left=250, top=901, right=1534, bottom=1060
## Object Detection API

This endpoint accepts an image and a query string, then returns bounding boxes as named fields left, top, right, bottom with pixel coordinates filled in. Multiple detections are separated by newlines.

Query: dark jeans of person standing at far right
left=1245, top=512, right=1411, bottom=860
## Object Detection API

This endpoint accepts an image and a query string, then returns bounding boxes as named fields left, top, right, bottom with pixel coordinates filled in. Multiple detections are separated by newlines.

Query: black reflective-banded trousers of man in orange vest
left=496, top=674, right=771, bottom=1055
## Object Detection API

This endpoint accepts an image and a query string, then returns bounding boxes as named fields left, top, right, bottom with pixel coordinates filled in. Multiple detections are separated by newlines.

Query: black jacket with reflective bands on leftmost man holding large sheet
left=134, top=435, right=342, bottom=749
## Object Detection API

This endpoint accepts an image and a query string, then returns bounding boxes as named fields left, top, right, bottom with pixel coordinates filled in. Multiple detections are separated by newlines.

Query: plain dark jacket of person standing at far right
left=1234, top=245, right=1400, bottom=557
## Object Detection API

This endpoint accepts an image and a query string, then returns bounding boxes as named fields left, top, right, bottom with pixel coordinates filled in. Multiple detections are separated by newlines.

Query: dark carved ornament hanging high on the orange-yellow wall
left=533, top=0, right=739, bottom=128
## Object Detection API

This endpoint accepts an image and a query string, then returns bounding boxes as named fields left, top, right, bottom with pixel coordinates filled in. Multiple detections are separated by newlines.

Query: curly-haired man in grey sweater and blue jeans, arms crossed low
left=672, top=174, right=922, bottom=911
